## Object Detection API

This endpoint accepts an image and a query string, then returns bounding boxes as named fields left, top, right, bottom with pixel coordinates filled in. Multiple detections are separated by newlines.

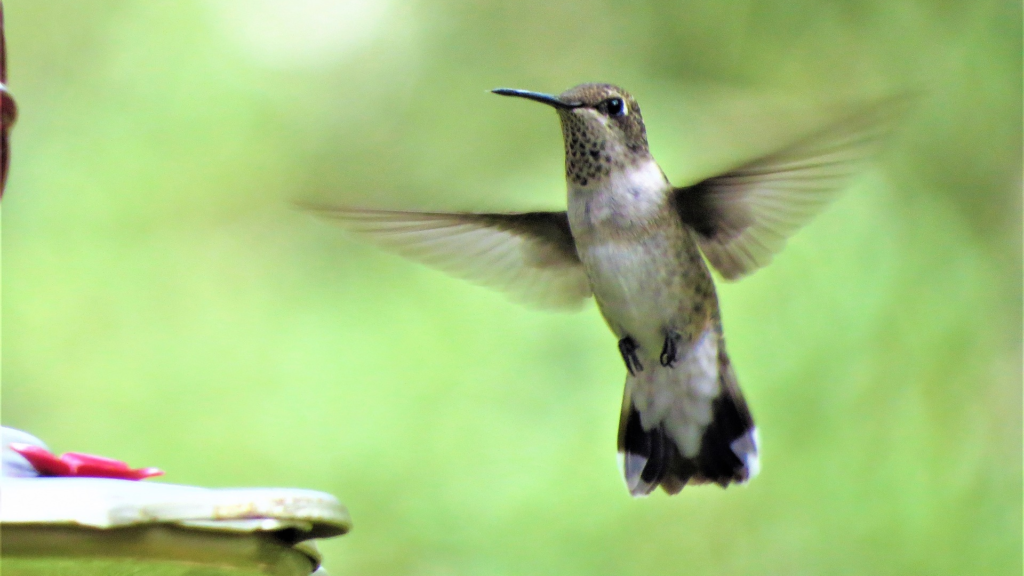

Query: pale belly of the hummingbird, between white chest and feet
left=581, top=235, right=692, bottom=356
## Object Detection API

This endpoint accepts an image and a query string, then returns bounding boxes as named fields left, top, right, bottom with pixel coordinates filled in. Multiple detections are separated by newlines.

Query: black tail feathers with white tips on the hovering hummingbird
left=618, top=345, right=758, bottom=496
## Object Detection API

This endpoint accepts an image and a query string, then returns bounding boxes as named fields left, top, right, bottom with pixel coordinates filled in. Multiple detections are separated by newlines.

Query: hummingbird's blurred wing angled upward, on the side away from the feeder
left=675, top=96, right=906, bottom=280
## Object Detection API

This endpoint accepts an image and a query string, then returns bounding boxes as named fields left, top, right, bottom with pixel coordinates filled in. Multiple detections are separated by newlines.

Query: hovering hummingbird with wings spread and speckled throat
left=307, top=84, right=894, bottom=496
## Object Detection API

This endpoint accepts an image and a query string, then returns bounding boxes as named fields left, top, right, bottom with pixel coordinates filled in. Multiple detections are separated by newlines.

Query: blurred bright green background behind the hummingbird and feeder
left=2, top=0, right=1022, bottom=575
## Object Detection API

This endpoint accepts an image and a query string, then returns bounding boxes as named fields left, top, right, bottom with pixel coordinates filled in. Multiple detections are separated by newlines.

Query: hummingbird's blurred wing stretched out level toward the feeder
left=308, top=206, right=591, bottom=308
